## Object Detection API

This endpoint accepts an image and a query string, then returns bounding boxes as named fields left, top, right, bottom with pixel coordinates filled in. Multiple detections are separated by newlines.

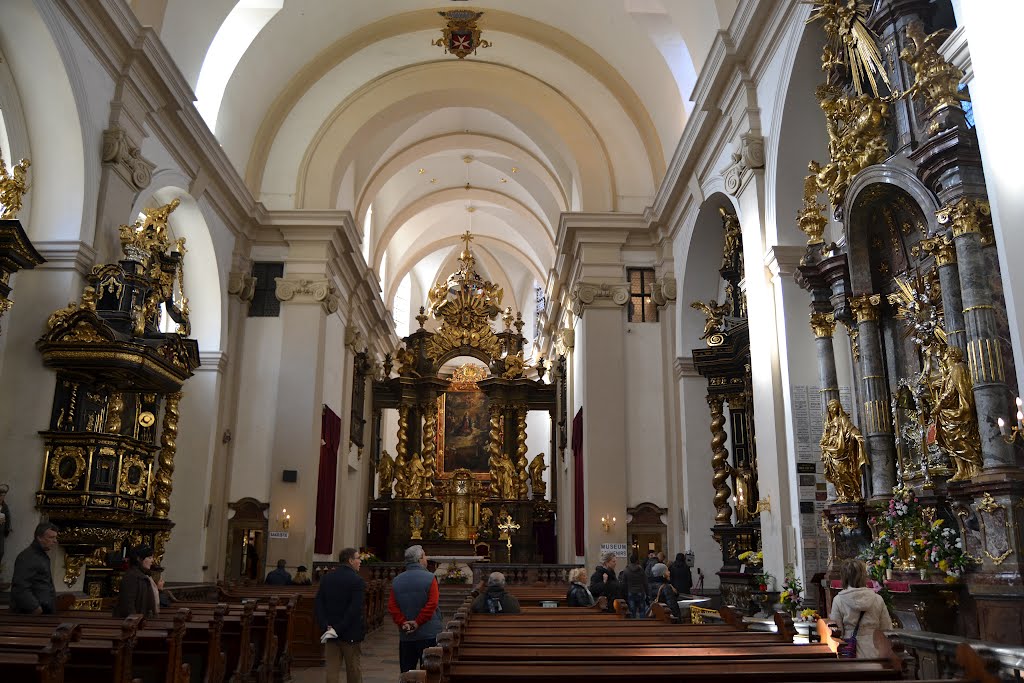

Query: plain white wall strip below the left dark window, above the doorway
left=228, top=317, right=282, bottom=501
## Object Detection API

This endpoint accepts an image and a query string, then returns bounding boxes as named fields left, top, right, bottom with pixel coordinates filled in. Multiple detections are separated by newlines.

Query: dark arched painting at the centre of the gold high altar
left=437, top=387, right=490, bottom=479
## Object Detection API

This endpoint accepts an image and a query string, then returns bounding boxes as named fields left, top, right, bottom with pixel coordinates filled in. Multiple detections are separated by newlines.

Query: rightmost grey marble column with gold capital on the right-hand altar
left=936, top=198, right=1016, bottom=470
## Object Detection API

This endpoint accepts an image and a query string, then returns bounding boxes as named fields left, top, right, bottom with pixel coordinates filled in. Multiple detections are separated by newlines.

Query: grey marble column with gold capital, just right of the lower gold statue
left=850, top=294, right=896, bottom=499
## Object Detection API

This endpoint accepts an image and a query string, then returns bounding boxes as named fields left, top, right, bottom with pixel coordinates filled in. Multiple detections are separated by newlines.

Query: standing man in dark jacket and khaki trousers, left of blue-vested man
left=319, top=548, right=367, bottom=683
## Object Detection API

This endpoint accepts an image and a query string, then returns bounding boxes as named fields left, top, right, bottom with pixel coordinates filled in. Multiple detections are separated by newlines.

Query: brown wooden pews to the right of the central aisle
left=401, top=587, right=994, bottom=683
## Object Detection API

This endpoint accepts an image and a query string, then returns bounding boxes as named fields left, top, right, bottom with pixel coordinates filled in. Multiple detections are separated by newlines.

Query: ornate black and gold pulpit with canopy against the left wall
left=36, top=200, right=199, bottom=597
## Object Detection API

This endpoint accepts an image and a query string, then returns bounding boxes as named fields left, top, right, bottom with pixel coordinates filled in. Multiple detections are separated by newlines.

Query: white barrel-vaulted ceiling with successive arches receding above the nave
left=144, top=0, right=738, bottom=325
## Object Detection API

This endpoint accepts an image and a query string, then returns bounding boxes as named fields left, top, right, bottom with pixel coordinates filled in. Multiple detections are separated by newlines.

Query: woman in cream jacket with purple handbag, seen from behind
left=828, top=560, right=893, bottom=658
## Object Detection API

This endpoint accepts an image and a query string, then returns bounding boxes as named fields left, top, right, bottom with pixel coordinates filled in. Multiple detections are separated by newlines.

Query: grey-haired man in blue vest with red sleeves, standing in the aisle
left=387, top=546, right=441, bottom=673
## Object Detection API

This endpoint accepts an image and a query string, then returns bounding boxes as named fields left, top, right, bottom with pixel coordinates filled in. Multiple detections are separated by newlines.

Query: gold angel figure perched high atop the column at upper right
left=899, top=19, right=971, bottom=116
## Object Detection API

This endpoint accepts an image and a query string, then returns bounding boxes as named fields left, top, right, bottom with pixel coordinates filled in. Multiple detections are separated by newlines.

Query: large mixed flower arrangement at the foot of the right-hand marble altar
left=860, top=484, right=976, bottom=584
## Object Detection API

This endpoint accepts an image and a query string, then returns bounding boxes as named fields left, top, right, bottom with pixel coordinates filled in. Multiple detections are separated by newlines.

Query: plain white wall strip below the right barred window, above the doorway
left=626, top=323, right=668, bottom=507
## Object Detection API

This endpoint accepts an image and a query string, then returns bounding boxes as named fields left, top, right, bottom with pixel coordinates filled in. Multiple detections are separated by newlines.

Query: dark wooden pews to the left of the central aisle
left=0, top=588, right=298, bottom=683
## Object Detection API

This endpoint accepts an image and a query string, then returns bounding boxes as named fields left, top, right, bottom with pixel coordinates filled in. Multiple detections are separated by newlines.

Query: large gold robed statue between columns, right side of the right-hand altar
left=932, top=346, right=981, bottom=481
